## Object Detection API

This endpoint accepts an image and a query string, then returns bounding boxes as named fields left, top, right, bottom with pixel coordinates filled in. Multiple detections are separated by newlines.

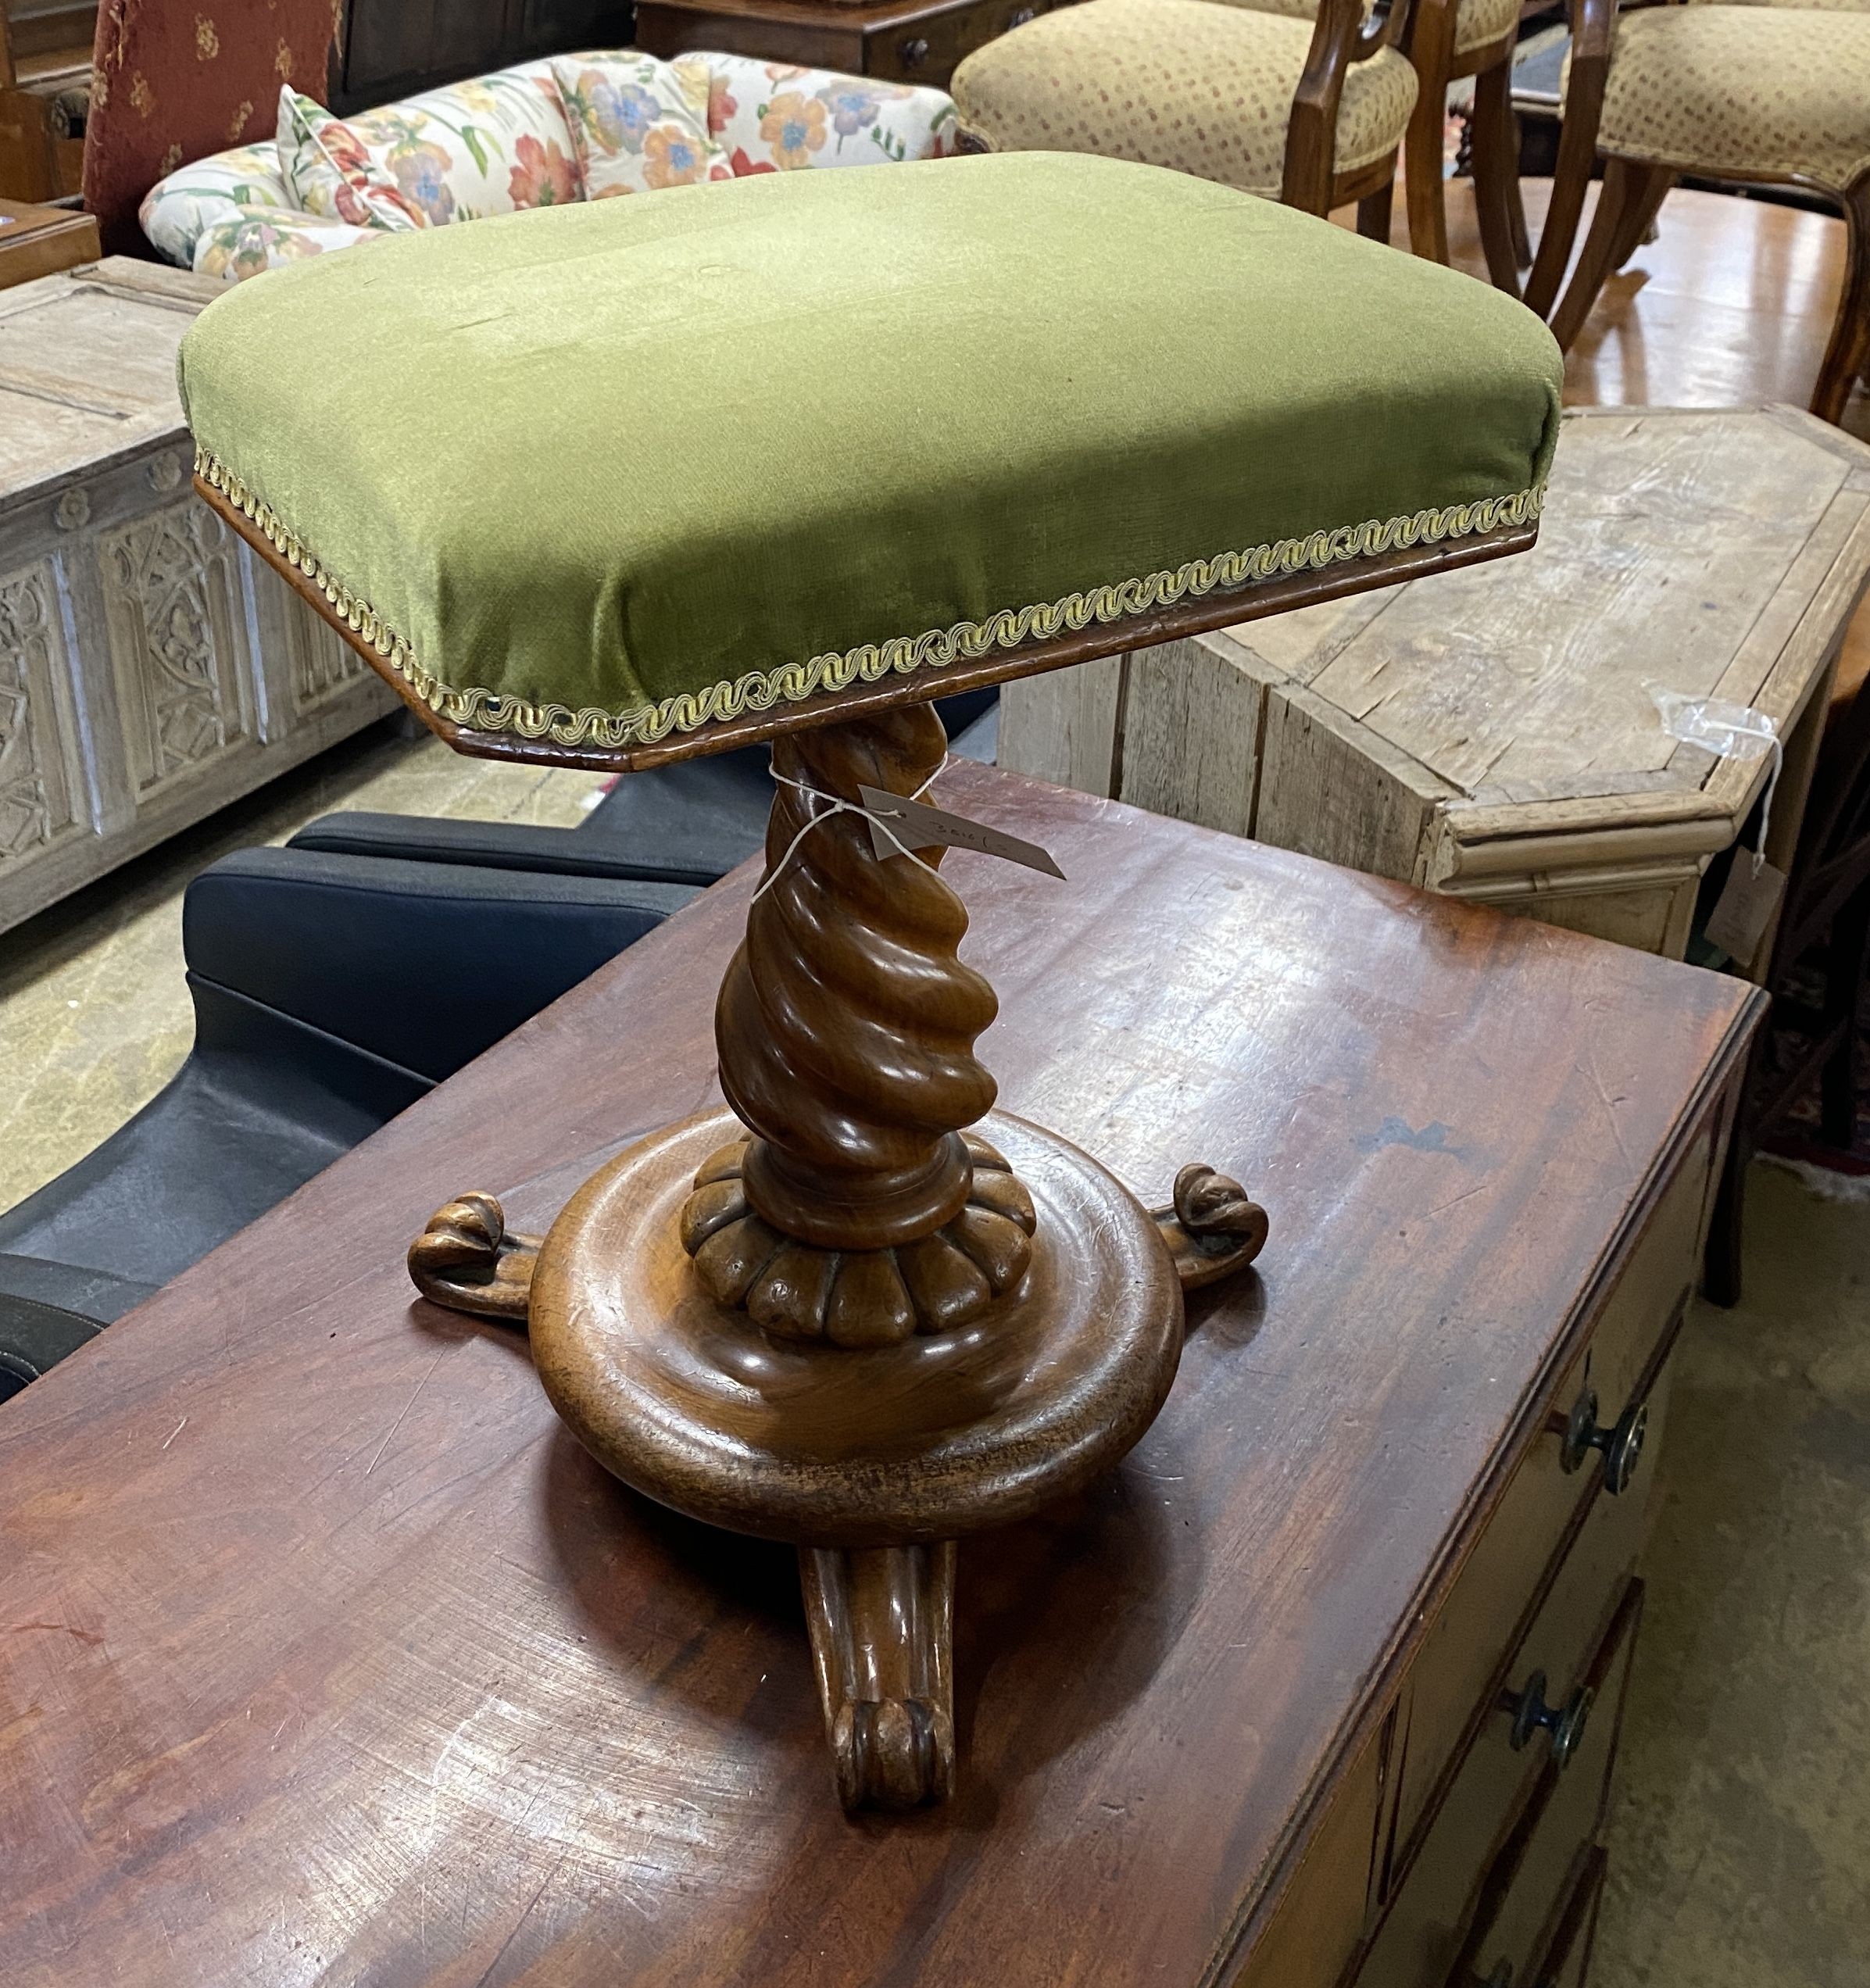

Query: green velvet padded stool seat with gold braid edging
left=181, top=153, right=1560, bottom=749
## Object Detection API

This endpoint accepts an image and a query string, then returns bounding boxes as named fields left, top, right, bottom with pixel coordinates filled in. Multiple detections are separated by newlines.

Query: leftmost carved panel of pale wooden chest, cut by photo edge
left=0, top=567, right=80, bottom=874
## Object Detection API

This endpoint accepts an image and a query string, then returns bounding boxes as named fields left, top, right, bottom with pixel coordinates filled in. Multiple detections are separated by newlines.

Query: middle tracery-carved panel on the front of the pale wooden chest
left=98, top=497, right=252, bottom=796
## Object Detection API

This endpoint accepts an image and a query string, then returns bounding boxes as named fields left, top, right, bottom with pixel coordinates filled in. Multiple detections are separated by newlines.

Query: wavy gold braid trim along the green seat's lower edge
left=195, top=447, right=1546, bottom=749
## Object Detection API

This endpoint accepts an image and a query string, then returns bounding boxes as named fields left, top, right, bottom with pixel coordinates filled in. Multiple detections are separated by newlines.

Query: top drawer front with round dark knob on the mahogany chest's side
left=1395, top=1129, right=1713, bottom=1857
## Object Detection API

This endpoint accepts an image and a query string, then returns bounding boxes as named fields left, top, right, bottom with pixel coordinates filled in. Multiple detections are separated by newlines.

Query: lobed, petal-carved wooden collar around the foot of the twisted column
left=681, top=1133, right=1037, bottom=1346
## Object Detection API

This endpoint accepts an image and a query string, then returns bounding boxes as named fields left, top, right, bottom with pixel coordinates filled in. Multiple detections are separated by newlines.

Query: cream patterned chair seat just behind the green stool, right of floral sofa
left=950, top=0, right=1415, bottom=198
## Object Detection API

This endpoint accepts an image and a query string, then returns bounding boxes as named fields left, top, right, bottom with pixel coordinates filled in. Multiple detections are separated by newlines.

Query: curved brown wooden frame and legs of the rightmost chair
left=1526, top=0, right=1870, bottom=424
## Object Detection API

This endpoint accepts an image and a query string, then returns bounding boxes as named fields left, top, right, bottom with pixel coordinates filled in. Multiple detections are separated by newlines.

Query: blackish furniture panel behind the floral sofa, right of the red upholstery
left=334, top=0, right=636, bottom=111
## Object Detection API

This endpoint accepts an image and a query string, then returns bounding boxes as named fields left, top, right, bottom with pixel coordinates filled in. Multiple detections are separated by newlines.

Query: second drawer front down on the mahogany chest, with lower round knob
left=1357, top=1371, right=1669, bottom=1988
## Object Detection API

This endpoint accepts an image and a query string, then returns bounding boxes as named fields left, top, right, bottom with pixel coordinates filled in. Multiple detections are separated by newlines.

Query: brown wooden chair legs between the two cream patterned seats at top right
left=1403, top=0, right=1529, bottom=296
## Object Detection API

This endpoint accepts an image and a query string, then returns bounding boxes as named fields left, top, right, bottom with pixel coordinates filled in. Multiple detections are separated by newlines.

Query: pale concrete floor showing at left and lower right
left=0, top=728, right=1870, bottom=1988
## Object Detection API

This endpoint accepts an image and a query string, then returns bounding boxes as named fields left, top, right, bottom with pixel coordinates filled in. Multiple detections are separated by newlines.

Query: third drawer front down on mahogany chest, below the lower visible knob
left=1463, top=1580, right=1643, bottom=1982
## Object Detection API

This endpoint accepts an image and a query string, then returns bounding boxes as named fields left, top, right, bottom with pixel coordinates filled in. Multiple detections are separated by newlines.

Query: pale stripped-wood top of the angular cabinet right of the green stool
left=1203, top=408, right=1870, bottom=849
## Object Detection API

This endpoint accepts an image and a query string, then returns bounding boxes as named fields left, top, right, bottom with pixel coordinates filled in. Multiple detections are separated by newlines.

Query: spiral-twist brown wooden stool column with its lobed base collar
left=681, top=706, right=1033, bottom=1346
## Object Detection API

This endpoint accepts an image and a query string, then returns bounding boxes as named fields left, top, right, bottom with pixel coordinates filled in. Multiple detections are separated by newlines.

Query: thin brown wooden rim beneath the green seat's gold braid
left=195, top=477, right=1538, bottom=774
